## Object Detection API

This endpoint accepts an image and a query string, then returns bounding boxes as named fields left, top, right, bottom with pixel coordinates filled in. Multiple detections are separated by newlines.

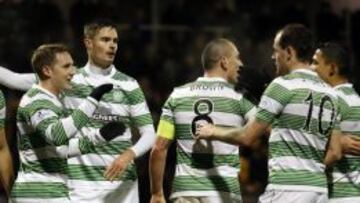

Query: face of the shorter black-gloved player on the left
left=49, top=52, right=75, bottom=91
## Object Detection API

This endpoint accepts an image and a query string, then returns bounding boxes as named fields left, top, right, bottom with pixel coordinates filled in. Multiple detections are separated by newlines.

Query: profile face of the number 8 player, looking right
left=228, top=44, right=244, bottom=84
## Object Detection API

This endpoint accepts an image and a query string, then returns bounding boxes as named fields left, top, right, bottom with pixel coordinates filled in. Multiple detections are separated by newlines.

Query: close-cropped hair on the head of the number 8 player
left=201, top=38, right=237, bottom=70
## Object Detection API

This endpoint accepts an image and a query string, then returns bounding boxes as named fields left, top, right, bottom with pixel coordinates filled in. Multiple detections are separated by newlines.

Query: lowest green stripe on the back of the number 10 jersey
left=269, top=170, right=327, bottom=188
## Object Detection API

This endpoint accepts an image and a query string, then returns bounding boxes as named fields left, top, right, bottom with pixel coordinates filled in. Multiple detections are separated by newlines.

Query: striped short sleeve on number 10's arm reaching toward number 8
left=256, top=78, right=292, bottom=123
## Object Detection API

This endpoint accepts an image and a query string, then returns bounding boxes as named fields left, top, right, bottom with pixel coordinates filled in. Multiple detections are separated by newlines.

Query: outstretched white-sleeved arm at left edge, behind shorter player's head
left=0, top=66, right=36, bottom=91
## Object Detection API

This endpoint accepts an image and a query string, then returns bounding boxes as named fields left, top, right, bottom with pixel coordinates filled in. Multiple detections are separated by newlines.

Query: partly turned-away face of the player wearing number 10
left=272, top=32, right=289, bottom=76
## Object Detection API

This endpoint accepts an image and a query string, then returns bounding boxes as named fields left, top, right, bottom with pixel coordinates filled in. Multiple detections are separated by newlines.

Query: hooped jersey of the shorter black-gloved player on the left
left=11, top=85, right=97, bottom=202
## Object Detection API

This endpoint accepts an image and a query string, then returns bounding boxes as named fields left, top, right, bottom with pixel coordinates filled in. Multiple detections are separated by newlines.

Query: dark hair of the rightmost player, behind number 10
left=319, top=42, right=351, bottom=77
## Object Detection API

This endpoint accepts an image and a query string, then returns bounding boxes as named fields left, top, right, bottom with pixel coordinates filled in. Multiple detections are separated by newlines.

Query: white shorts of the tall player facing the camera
left=69, top=181, right=140, bottom=203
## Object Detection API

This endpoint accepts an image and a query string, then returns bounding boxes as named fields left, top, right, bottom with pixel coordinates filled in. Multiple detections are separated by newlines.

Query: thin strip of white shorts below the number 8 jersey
left=172, top=197, right=241, bottom=203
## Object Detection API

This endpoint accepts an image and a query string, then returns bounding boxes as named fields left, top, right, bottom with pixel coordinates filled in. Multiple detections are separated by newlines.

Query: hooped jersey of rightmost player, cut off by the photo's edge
left=330, top=83, right=360, bottom=202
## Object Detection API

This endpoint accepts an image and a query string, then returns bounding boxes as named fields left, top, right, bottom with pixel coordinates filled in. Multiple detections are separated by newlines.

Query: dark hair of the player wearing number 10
left=279, top=24, right=315, bottom=62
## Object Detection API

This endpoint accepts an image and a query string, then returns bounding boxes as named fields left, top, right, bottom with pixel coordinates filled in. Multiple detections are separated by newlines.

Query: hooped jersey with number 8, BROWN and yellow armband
left=157, top=77, right=256, bottom=199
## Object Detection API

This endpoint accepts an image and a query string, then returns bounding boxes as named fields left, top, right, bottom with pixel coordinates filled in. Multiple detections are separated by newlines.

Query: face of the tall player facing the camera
left=85, top=27, right=118, bottom=68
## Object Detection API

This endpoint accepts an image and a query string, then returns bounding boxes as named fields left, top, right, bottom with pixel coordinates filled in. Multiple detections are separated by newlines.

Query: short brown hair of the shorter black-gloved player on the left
left=31, top=44, right=70, bottom=80
